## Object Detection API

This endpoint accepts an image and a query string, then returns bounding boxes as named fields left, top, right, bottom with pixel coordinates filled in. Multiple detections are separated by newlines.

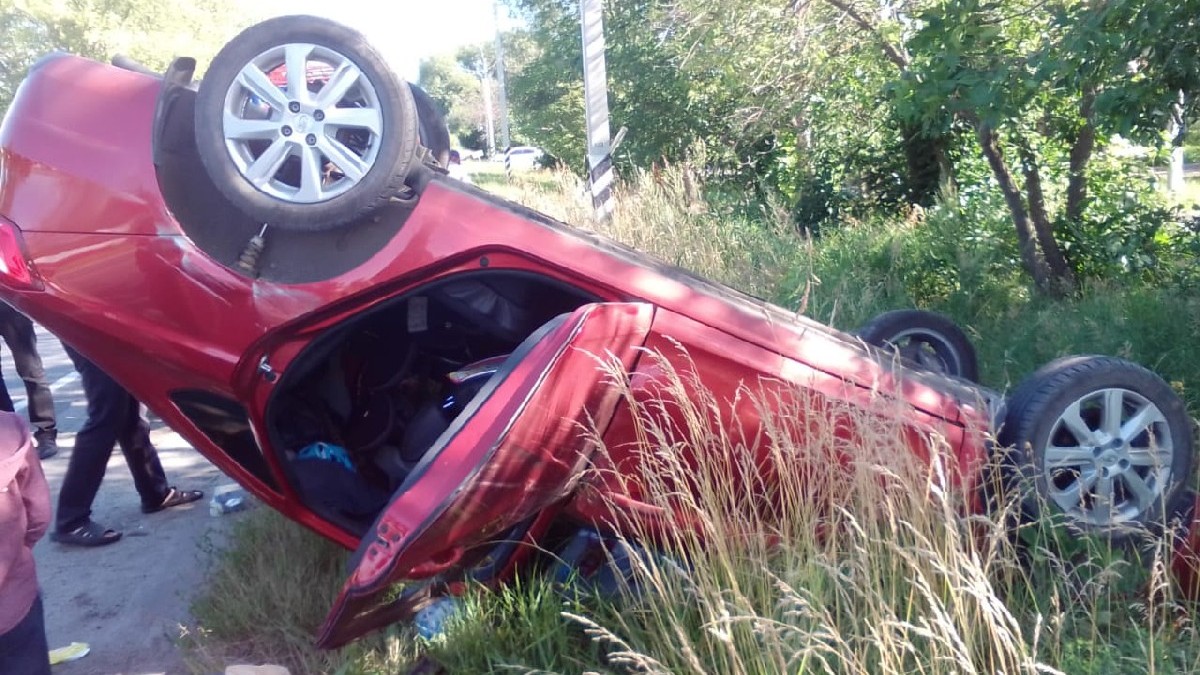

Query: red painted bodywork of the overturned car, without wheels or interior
left=0, top=56, right=1190, bottom=646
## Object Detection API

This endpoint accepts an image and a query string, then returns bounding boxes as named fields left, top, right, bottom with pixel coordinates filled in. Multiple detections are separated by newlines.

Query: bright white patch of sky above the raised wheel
left=242, top=0, right=515, bottom=82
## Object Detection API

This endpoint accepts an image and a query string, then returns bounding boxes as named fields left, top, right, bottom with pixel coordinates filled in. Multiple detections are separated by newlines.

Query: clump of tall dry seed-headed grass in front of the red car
left=571, top=353, right=1045, bottom=674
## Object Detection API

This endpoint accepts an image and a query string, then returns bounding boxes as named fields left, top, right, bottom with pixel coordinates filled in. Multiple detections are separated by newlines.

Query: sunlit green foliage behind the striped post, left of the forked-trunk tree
left=510, top=0, right=936, bottom=219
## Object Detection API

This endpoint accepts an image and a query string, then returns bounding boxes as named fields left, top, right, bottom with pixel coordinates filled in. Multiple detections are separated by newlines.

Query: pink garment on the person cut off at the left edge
left=0, top=412, right=50, bottom=635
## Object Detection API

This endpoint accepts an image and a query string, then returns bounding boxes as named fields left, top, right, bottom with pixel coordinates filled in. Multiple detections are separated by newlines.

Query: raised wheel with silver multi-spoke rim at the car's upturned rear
left=196, top=16, right=419, bottom=232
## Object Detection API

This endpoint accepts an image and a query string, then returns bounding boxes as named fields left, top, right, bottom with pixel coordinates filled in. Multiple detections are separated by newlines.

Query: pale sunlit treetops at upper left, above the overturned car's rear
left=0, top=0, right=246, bottom=109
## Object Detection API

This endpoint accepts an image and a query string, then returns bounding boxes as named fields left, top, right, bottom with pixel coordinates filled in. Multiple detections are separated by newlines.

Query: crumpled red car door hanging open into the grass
left=318, top=303, right=654, bottom=647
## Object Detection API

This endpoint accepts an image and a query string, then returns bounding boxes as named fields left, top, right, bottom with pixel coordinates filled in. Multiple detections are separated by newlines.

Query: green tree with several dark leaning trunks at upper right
left=898, top=0, right=1200, bottom=294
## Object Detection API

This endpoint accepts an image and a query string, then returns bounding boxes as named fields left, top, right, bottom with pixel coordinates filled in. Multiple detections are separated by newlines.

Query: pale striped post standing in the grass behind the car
left=580, top=0, right=613, bottom=220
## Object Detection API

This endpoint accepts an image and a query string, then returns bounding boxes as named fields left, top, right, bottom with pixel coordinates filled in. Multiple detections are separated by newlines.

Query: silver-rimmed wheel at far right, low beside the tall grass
left=997, top=356, right=1195, bottom=540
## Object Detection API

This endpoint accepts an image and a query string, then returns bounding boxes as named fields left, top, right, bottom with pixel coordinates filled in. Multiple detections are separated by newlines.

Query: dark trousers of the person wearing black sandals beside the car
left=55, top=345, right=170, bottom=532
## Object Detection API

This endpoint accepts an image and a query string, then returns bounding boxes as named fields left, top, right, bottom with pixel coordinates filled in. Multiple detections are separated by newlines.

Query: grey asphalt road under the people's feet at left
left=9, top=328, right=239, bottom=675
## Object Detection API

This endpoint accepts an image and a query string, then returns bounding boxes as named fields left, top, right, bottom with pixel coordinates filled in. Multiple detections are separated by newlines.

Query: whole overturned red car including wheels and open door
left=0, top=17, right=1193, bottom=646
